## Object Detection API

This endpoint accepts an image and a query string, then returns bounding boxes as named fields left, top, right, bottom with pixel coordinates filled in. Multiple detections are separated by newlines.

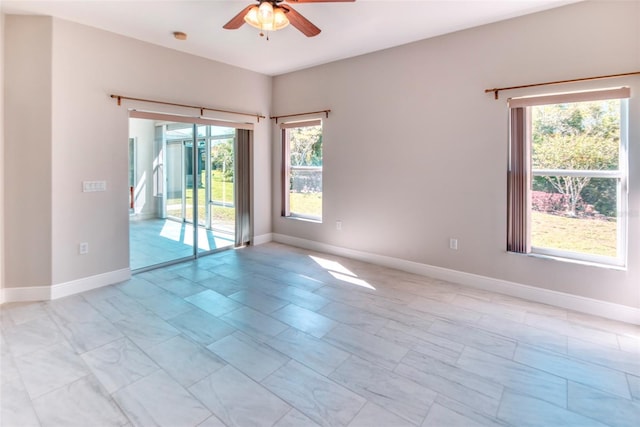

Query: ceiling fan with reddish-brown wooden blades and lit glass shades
left=222, top=0, right=355, bottom=37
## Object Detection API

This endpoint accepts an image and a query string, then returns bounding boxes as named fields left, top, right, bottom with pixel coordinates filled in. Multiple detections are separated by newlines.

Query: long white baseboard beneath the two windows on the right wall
left=273, top=234, right=640, bottom=325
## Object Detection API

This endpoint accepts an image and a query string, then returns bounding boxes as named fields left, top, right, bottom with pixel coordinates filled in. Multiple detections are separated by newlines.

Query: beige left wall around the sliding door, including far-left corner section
left=5, top=15, right=271, bottom=287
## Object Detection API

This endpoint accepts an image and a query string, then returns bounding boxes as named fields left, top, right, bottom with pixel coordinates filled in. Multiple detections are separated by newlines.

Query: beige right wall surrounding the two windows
left=272, top=1, right=640, bottom=307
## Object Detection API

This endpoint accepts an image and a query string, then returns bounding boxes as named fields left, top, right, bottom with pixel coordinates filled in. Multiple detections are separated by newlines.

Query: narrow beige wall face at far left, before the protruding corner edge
left=3, top=16, right=54, bottom=287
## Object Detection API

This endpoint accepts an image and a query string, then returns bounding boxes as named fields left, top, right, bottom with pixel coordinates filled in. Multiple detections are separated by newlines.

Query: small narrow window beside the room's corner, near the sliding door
left=282, top=120, right=322, bottom=221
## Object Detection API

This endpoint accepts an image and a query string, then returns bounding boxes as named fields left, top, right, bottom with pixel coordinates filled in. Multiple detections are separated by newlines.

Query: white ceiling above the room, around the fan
left=0, top=0, right=580, bottom=75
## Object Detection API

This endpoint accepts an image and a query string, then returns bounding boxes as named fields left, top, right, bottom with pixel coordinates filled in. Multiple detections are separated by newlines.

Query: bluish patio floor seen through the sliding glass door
left=129, top=219, right=234, bottom=270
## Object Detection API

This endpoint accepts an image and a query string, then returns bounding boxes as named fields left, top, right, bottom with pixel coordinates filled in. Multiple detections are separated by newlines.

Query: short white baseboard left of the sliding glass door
left=0, top=268, right=131, bottom=303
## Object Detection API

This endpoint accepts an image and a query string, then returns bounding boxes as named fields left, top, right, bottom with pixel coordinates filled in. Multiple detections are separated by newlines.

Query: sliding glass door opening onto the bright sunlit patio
left=129, top=113, right=246, bottom=270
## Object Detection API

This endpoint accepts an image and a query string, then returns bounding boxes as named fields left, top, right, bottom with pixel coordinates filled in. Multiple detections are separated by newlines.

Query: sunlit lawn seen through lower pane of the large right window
left=531, top=212, right=617, bottom=257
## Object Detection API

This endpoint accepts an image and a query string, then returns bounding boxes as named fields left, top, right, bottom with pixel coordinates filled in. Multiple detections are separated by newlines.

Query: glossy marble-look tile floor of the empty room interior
left=0, top=243, right=640, bottom=427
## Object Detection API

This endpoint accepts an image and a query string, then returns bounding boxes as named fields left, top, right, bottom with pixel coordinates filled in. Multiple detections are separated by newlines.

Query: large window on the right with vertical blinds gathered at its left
left=507, top=88, right=629, bottom=266
